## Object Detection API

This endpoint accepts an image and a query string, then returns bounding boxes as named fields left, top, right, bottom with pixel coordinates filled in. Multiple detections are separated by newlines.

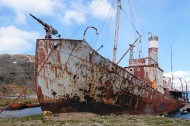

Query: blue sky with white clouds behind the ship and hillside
left=0, top=0, right=190, bottom=89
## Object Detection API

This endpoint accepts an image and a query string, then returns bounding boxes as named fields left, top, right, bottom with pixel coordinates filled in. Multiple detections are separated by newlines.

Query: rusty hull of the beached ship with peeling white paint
left=35, top=39, right=184, bottom=114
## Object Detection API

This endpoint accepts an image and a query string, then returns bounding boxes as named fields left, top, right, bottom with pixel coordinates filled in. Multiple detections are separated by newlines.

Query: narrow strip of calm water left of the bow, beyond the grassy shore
left=0, top=107, right=42, bottom=118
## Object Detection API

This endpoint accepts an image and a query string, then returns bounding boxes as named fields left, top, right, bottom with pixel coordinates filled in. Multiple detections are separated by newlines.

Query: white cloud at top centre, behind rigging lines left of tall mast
left=62, top=0, right=115, bottom=25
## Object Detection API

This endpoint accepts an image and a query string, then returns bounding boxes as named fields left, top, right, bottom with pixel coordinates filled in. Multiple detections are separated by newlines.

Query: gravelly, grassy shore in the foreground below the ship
left=0, top=113, right=190, bottom=126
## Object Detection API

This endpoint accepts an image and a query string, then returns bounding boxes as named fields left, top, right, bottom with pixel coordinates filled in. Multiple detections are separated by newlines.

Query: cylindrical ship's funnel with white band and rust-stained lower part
left=148, top=36, right=158, bottom=65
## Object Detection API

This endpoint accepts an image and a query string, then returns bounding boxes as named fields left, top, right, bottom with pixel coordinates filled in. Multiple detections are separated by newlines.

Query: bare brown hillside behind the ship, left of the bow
left=0, top=54, right=35, bottom=94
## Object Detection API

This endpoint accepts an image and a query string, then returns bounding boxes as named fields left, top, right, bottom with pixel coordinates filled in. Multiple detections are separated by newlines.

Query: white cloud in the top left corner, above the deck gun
left=0, top=0, right=65, bottom=24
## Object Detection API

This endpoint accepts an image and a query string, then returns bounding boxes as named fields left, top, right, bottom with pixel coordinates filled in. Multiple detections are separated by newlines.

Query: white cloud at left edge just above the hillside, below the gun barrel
left=0, top=26, right=39, bottom=54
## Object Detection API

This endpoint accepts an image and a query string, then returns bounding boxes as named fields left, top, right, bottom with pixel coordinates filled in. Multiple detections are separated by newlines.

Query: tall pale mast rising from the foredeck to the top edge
left=113, top=0, right=121, bottom=63
